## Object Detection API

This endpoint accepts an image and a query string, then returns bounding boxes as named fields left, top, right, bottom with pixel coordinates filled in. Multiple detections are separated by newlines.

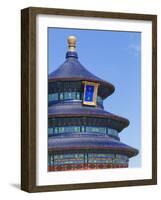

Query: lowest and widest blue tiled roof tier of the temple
left=48, top=135, right=138, bottom=157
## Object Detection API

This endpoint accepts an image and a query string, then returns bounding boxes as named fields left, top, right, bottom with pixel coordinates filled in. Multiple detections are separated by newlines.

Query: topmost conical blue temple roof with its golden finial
left=48, top=36, right=115, bottom=98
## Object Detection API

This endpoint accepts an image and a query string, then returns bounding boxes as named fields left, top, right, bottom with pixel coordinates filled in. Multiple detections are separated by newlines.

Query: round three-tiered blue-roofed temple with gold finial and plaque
left=48, top=36, right=138, bottom=171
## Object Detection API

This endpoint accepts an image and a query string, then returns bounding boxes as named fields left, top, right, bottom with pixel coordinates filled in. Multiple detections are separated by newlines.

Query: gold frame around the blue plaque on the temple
left=83, top=81, right=100, bottom=106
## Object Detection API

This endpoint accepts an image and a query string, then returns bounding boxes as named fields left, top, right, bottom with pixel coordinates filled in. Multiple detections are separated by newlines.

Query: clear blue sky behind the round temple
left=48, top=28, right=141, bottom=167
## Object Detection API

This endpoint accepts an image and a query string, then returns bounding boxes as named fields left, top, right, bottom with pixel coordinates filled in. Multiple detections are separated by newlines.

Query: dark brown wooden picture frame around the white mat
left=21, top=7, right=157, bottom=192
